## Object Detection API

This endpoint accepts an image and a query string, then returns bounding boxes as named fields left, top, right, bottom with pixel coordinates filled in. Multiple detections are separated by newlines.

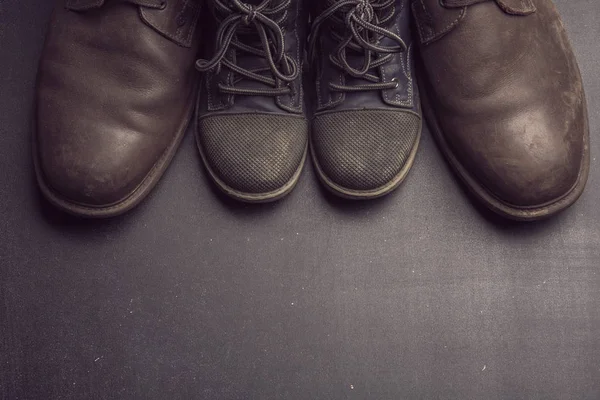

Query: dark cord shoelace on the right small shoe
left=309, top=0, right=407, bottom=92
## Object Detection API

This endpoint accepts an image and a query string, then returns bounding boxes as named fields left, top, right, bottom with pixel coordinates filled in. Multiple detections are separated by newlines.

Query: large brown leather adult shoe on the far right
left=412, top=0, right=590, bottom=220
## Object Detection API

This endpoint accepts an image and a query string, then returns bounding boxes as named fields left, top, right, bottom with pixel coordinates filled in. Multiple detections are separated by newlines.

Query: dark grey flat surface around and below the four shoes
left=0, top=0, right=600, bottom=400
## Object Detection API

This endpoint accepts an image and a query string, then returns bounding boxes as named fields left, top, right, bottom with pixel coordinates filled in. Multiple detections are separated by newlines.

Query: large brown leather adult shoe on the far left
left=34, top=0, right=200, bottom=217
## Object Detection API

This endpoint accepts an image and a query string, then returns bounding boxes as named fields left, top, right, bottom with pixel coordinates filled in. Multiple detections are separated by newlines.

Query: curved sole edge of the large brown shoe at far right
left=417, top=64, right=590, bottom=221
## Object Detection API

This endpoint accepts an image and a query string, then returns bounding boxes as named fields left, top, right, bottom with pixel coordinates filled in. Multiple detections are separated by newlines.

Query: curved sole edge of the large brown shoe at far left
left=32, top=85, right=196, bottom=218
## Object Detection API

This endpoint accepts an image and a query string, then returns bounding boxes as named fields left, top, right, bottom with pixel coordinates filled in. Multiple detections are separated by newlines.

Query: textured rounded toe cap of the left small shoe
left=198, top=114, right=308, bottom=195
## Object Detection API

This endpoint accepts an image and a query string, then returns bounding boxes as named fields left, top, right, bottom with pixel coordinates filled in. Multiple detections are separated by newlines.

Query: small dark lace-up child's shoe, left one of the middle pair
left=196, top=0, right=308, bottom=202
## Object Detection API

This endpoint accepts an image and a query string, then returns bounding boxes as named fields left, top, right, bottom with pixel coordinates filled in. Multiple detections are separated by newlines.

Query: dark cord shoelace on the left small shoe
left=196, top=0, right=300, bottom=96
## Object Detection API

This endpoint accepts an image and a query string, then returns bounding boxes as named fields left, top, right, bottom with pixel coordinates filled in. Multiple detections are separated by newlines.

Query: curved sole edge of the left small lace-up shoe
left=194, top=118, right=308, bottom=204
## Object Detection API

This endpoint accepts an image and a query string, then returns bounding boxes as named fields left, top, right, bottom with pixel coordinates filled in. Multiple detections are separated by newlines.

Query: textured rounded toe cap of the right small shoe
left=312, top=110, right=421, bottom=192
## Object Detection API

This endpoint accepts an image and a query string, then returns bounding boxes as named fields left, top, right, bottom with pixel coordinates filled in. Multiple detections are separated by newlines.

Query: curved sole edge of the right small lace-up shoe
left=310, top=120, right=423, bottom=200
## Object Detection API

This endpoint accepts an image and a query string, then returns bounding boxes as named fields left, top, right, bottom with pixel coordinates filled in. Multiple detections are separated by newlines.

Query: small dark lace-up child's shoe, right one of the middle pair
left=308, top=0, right=421, bottom=199
